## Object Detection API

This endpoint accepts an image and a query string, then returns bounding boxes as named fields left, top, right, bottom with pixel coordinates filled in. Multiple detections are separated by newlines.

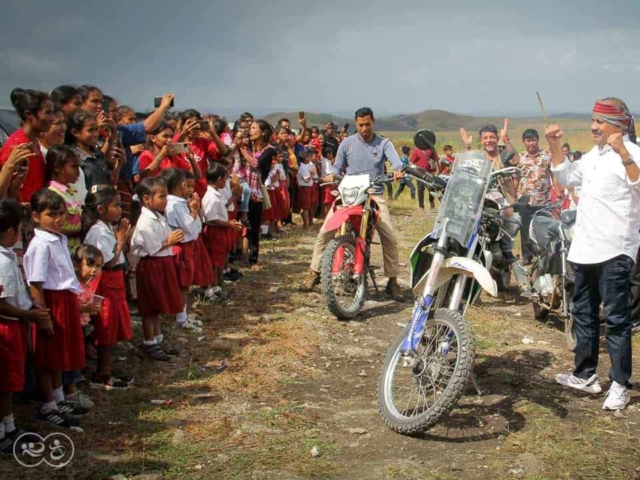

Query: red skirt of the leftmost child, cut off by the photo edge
left=0, top=318, right=28, bottom=393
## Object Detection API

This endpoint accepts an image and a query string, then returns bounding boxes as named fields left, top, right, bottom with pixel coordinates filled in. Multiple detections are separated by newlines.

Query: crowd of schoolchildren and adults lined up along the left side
left=0, top=85, right=345, bottom=453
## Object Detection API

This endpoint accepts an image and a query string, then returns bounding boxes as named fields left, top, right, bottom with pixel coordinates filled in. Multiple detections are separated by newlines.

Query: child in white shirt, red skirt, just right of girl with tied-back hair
left=131, top=178, right=185, bottom=362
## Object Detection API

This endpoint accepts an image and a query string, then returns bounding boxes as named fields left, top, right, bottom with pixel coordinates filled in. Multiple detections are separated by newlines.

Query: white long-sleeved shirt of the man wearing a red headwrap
left=551, top=136, right=640, bottom=265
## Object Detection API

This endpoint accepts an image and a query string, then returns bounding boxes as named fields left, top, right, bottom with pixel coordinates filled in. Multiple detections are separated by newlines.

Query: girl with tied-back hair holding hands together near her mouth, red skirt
left=78, top=185, right=131, bottom=389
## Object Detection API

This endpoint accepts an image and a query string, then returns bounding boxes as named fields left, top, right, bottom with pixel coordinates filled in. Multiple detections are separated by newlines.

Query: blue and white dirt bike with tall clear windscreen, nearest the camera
left=378, top=132, right=510, bottom=435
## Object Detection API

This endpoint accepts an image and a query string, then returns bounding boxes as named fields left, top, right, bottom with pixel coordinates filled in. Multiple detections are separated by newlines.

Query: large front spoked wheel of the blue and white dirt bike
left=378, top=309, right=475, bottom=435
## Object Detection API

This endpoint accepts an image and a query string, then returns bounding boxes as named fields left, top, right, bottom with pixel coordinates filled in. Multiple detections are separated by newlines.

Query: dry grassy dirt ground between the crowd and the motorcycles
left=0, top=203, right=640, bottom=480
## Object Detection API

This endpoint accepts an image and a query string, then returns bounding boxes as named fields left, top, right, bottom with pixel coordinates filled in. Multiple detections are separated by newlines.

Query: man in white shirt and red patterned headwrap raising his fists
left=546, top=98, right=640, bottom=410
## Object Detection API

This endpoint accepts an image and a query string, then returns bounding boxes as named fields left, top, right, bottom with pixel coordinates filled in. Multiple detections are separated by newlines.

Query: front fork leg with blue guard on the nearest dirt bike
left=400, top=228, right=448, bottom=358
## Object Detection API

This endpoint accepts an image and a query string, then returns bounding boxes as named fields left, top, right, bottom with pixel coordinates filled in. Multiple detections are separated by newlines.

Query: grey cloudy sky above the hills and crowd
left=0, top=0, right=640, bottom=115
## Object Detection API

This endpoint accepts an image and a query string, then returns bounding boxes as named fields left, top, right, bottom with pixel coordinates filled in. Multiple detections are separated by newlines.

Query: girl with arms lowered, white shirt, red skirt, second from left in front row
left=24, top=189, right=87, bottom=427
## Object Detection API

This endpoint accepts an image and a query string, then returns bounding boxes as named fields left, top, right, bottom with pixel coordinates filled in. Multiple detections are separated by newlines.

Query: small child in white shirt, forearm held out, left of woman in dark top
left=202, top=163, right=243, bottom=287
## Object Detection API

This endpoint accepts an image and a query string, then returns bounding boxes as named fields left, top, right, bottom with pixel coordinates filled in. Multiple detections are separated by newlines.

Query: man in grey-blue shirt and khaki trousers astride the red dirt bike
left=300, top=107, right=403, bottom=300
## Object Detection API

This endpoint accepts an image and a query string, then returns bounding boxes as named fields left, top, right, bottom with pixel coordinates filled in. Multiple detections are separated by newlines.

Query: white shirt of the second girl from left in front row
left=23, top=228, right=82, bottom=294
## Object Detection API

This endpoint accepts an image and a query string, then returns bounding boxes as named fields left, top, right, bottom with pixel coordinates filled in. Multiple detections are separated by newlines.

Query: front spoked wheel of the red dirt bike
left=321, top=235, right=367, bottom=320
